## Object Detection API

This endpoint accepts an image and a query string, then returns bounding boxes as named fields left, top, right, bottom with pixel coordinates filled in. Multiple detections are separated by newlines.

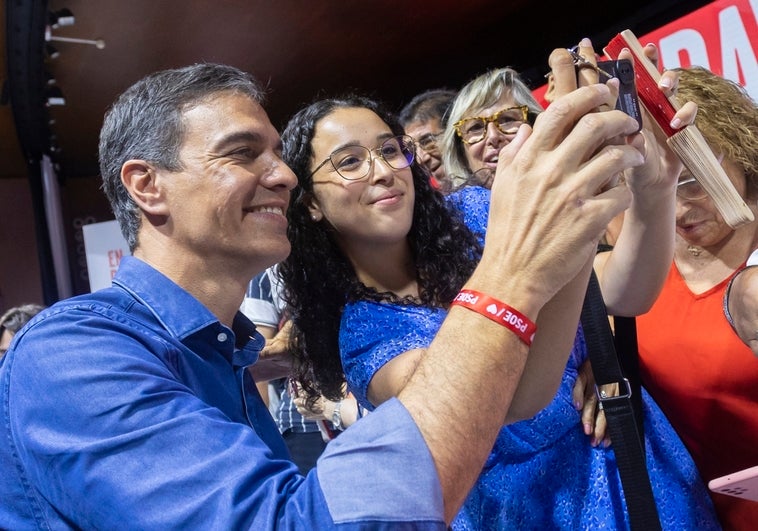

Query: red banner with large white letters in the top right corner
left=534, top=0, right=758, bottom=103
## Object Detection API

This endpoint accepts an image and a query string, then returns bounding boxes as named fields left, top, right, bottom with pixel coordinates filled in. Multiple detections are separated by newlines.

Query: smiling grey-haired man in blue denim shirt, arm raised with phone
left=0, top=60, right=638, bottom=529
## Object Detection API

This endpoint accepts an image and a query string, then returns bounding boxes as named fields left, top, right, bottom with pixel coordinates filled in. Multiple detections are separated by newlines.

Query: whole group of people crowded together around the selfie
left=0, top=30, right=758, bottom=530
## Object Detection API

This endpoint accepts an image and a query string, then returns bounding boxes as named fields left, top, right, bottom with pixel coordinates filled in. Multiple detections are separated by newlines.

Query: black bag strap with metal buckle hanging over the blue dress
left=582, top=271, right=661, bottom=531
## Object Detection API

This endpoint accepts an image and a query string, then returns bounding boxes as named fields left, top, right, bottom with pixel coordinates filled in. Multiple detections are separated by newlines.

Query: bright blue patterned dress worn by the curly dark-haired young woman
left=340, top=188, right=720, bottom=530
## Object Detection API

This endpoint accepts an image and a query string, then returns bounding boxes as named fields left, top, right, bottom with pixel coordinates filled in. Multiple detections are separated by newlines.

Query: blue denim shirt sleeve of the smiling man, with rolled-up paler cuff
left=0, top=302, right=444, bottom=529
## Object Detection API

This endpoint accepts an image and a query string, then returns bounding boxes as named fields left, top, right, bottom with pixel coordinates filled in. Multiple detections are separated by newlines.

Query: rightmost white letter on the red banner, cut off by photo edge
left=719, top=6, right=758, bottom=96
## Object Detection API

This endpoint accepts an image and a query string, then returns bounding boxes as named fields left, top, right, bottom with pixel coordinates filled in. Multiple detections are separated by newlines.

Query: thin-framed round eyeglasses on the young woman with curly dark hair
left=311, top=135, right=416, bottom=181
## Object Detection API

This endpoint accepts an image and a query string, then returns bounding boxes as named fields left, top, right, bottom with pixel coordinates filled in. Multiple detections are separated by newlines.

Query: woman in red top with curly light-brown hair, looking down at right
left=637, top=68, right=758, bottom=530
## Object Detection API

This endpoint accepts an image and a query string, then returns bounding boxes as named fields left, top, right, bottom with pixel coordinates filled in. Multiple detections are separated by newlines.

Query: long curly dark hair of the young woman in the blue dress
left=280, top=94, right=481, bottom=400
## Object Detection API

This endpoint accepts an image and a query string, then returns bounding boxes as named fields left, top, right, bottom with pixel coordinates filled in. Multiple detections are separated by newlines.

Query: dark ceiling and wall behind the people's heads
left=0, top=0, right=708, bottom=311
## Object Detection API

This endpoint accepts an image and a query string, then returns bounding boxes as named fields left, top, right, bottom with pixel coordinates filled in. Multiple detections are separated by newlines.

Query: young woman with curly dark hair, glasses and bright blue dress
left=281, top=61, right=715, bottom=529
